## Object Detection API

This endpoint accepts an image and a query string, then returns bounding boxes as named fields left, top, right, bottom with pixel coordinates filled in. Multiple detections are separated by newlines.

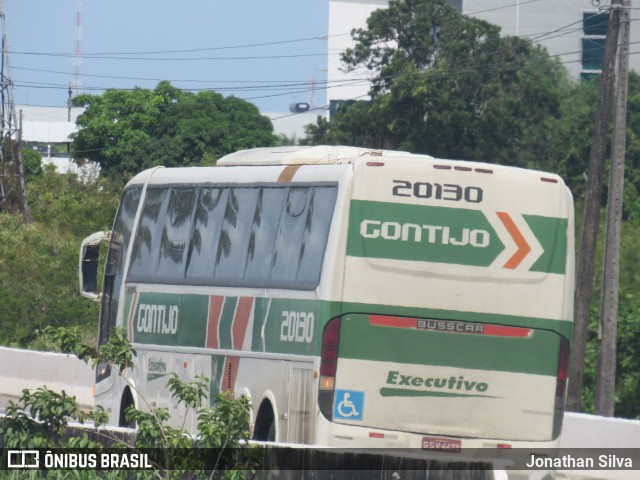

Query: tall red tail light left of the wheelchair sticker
left=318, top=318, right=340, bottom=420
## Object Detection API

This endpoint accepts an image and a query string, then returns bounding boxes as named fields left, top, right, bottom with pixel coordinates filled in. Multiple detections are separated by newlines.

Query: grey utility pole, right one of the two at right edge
left=595, top=0, right=631, bottom=417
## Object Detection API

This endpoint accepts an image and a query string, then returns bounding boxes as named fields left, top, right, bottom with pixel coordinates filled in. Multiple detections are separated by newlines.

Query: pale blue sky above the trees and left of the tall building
left=5, top=0, right=332, bottom=112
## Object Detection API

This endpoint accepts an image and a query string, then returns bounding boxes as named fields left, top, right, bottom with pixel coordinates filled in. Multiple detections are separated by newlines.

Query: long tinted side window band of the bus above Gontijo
left=130, top=186, right=337, bottom=290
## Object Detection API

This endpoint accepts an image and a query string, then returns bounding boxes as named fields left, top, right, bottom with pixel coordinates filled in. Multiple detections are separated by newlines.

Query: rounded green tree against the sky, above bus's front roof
left=71, top=82, right=277, bottom=177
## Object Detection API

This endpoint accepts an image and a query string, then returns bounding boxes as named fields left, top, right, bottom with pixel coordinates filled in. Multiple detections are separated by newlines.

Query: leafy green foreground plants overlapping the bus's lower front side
left=0, top=328, right=259, bottom=479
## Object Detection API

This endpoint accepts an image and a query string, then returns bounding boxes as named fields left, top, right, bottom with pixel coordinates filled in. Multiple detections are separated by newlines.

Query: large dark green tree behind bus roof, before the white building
left=310, top=0, right=569, bottom=166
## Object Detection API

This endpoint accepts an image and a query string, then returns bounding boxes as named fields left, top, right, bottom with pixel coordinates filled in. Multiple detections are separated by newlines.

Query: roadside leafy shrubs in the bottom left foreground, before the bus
left=0, top=327, right=260, bottom=480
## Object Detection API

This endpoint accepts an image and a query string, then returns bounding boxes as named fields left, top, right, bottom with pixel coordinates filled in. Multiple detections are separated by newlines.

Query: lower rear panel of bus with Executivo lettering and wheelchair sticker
left=320, top=314, right=568, bottom=450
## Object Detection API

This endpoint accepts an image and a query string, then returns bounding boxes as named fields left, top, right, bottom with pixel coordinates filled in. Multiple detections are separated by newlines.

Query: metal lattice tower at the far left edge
left=0, top=0, right=30, bottom=222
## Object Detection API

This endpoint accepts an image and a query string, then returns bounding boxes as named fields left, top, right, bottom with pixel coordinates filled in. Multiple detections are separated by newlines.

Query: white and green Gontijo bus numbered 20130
left=80, top=146, right=574, bottom=451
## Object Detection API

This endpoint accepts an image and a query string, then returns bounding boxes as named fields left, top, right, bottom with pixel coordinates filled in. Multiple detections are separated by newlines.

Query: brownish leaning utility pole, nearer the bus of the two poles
left=567, top=0, right=621, bottom=411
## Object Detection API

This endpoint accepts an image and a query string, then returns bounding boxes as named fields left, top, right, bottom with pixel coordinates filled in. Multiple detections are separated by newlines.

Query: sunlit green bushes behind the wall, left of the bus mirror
left=0, top=171, right=122, bottom=349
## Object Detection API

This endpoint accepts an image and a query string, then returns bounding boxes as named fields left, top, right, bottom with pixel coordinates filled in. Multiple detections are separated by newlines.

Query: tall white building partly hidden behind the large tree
left=327, top=0, right=640, bottom=109
